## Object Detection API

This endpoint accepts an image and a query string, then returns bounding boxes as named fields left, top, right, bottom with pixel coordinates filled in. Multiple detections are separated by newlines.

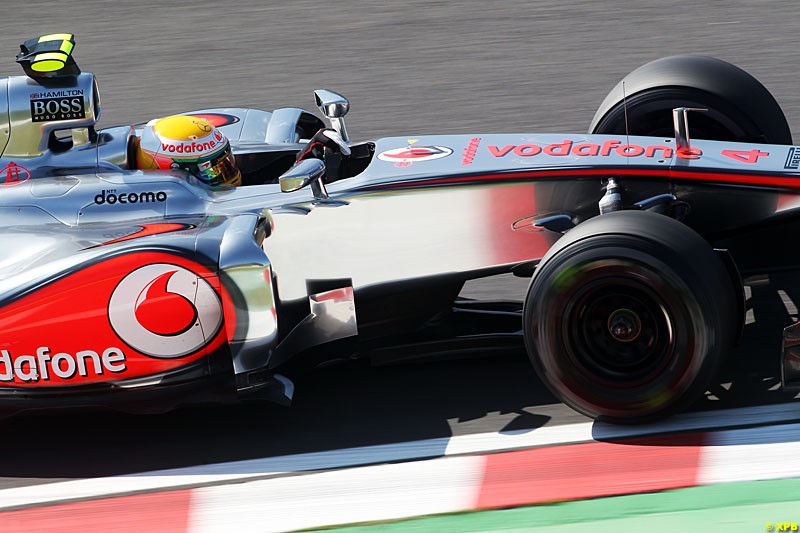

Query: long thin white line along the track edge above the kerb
left=0, top=403, right=800, bottom=510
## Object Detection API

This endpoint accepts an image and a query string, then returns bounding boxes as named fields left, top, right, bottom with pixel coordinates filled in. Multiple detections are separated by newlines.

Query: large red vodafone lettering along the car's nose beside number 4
left=487, top=139, right=703, bottom=159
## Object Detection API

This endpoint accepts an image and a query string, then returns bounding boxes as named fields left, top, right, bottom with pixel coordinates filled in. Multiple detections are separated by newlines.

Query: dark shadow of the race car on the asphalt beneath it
left=0, top=275, right=800, bottom=480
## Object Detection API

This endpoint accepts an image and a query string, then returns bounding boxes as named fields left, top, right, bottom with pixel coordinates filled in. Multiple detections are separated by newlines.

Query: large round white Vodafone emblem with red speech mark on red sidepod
left=108, top=263, right=222, bottom=359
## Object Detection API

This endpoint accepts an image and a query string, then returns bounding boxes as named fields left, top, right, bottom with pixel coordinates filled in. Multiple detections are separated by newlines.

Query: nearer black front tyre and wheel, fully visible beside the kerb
left=524, top=211, right=737, bottom=423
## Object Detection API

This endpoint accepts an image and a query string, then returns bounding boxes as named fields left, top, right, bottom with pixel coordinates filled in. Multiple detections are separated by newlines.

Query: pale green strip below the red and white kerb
left=324, top=479, right=800, bottom=533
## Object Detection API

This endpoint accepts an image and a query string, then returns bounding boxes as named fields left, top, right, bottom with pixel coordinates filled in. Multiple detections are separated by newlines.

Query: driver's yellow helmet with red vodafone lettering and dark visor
left=136, top=115, right=242, bottom=187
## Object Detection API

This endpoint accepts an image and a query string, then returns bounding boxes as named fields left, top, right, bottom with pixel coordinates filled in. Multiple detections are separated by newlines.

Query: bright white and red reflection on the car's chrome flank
left=264, top=183, right=560, bottom=300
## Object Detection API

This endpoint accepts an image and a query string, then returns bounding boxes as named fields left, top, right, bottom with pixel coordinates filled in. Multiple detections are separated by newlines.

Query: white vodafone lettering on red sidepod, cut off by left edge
left=0, top=346, right=127, bottom=383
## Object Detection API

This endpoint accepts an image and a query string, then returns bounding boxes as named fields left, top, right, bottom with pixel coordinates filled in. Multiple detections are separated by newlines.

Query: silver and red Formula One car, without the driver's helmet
left=0, top=34, right=800, bottom=422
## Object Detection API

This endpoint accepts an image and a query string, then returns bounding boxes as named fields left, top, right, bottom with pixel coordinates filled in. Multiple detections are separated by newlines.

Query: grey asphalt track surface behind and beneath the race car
left=0, top=0, right=800, bottom=500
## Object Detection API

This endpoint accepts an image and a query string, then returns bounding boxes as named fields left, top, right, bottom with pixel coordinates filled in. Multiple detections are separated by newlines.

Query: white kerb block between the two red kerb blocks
left=189, top=457, right=485, bottom=533
